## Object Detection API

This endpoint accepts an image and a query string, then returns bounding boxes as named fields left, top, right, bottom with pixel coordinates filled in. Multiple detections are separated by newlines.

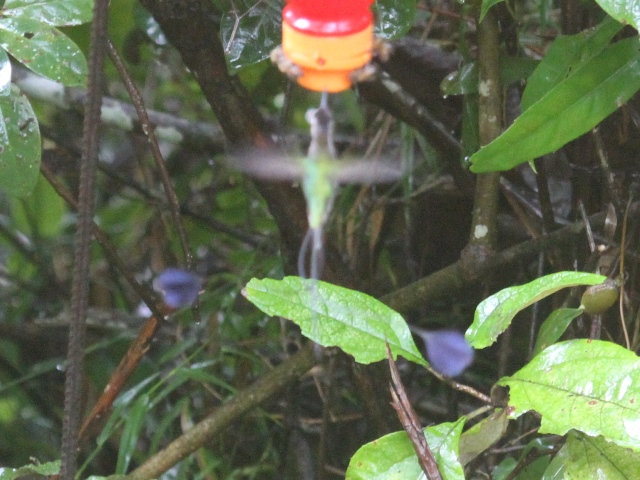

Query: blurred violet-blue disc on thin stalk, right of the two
left=411, top=327, right=474, bottom=377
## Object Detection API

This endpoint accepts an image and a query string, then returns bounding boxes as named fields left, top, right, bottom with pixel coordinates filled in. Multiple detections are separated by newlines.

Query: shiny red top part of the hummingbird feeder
left=282, top=0, right=373, bottom=36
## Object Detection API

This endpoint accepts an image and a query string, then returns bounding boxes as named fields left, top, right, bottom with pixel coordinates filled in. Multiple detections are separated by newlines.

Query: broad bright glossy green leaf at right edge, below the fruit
left=498, top=340, right=640, bottom=451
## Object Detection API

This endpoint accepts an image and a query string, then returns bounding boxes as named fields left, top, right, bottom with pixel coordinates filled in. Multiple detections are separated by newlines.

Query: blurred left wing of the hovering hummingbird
left=229, top=150, right=303, bottom=180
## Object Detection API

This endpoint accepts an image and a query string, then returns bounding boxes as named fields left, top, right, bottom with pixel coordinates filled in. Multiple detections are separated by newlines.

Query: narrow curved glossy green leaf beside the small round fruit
left=465, top=272, right=607, bottom=349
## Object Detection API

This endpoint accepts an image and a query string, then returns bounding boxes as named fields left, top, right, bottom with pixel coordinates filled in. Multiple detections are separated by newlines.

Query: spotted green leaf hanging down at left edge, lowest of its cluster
left=0, top=87, right=41, bottom=197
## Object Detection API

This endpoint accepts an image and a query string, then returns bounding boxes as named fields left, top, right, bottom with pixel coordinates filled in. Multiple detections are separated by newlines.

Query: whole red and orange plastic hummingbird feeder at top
left=282, top=0, right=374, bottom=93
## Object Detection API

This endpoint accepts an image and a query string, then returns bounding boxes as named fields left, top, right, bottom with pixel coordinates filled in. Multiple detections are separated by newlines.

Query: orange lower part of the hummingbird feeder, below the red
left=282, top=22, right=373, bottom=93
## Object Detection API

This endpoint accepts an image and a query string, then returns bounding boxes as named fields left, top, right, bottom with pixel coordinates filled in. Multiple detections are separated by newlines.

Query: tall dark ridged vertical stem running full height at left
left=60, top=0, right=109, bottom=480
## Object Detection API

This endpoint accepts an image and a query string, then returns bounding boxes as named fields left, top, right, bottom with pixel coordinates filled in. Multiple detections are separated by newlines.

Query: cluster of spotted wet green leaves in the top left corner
left=0, top=0, right=93, bottom=197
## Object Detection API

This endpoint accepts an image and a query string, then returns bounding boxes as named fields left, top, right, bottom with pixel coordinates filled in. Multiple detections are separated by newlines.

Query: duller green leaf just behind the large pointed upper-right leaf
left=520, top=17, right=622, bottom=112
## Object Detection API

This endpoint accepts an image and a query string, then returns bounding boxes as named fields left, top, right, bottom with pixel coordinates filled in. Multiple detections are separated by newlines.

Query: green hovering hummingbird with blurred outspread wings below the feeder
left=232, top=92, right=402, bottom=280
